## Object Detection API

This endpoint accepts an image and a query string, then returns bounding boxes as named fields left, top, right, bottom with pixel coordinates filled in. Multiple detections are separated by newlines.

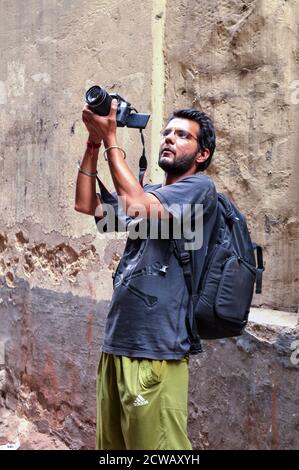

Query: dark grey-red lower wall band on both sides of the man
left=0, top=278, right=299, bottom=449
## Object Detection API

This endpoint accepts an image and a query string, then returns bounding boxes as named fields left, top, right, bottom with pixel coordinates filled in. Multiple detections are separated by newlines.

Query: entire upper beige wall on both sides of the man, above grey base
left=0, top=0, right=299, bottom=320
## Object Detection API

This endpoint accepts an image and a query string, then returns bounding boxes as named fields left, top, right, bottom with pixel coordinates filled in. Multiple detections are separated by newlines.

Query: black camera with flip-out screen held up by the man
left=85, top=85, right=150, bottom=129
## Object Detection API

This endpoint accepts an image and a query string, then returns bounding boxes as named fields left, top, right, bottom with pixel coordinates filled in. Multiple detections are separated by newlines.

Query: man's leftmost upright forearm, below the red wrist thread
left=75, top=142, right=101, bottom=216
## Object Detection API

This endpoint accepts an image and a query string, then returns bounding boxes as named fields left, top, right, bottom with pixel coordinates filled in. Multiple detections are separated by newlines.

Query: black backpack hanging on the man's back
left=174, top=193, right=264, bottom=346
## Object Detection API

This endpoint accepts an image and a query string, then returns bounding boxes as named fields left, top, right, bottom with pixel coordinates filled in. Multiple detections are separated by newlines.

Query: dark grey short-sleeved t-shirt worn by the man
left=96, top=173, right=217, bottom=360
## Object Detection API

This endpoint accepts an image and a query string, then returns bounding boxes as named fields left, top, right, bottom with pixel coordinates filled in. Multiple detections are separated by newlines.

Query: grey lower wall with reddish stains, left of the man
left=0, top=279, right=108, bottom=449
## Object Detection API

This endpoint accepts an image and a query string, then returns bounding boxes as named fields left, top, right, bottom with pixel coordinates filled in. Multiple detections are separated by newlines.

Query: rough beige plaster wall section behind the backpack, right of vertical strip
left=165, top=0, right=299, bottom=311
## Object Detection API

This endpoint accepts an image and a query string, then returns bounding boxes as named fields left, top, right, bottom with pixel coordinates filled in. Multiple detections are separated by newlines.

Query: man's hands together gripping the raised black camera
left=82, top=99, right=117, bottom=147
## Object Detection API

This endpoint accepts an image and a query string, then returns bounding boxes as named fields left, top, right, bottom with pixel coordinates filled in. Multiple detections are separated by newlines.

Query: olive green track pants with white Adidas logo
left=96, top=353, right=191, bottom=450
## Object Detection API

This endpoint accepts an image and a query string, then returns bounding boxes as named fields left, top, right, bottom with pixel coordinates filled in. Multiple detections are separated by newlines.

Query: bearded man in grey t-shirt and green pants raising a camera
left=75, top=100, right=216, bottom=450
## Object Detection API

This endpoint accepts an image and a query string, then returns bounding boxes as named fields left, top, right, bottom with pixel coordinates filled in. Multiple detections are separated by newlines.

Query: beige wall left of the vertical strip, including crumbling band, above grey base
left=0, top=0, right=153, bottom=298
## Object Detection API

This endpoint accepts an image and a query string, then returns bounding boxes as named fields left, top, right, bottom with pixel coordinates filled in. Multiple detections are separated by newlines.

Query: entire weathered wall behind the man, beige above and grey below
left=0, top=0, right=299, bottom=449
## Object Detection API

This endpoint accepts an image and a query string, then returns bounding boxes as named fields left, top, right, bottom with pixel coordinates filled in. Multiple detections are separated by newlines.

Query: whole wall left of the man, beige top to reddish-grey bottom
left=0, top=0, right=153, bottom=448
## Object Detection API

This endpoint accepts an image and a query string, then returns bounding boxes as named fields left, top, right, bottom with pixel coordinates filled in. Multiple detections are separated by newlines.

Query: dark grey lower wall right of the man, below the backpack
left=189, top=323, right=299, bottom=450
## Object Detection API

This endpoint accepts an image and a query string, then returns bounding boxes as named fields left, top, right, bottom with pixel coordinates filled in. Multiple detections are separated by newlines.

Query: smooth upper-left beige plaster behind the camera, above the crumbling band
left=0, top=0, right=152, bottom=237
